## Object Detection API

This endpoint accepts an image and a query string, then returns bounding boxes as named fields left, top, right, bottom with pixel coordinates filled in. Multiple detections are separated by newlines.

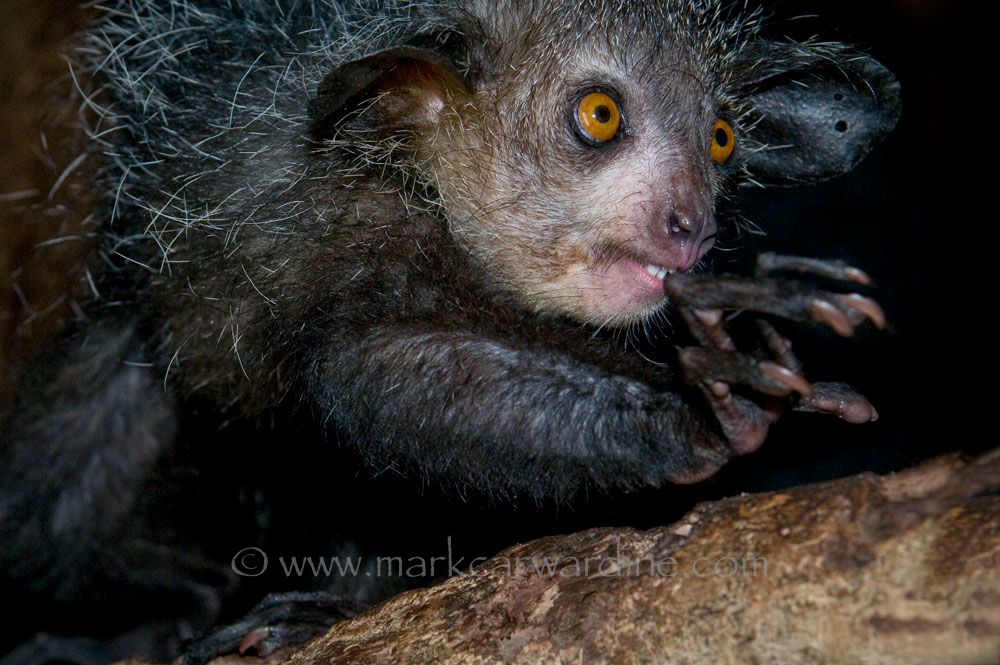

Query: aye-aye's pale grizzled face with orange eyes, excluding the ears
left=418, top=8, right=739, bottom=325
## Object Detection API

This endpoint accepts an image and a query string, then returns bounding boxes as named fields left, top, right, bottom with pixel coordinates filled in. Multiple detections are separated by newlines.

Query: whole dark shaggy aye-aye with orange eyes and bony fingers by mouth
left=0, top=0, right=899, bottom=660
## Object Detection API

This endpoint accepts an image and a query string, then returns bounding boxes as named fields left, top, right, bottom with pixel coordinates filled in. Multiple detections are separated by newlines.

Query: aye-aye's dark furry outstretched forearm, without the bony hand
left=312, top=326, right=735, bottom=498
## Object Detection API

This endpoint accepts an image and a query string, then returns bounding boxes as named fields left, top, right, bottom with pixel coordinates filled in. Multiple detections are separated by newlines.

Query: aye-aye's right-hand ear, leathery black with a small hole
left=740, top=41, right=902, bottom=185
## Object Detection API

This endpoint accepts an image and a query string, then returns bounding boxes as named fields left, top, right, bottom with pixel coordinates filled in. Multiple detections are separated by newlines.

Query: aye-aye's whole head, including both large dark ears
left=311, top=0, right=899, bottom=325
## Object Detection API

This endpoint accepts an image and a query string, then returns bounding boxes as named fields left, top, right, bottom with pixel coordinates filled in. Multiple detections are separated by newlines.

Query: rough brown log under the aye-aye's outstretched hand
left=285, top=451, right=1000, bottom=665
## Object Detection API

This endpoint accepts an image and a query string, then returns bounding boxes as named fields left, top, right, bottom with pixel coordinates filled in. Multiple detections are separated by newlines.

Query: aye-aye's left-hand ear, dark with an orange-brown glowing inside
left=309, top=40, right=469, bottom=139
